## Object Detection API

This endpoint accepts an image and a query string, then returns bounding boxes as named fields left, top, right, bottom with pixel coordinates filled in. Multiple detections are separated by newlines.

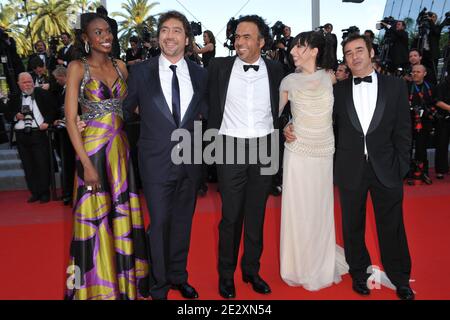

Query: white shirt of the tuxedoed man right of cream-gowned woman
left=353, top=71, right=378, bottom=157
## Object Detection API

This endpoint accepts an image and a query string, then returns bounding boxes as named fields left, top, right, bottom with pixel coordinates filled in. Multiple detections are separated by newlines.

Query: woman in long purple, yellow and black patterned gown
left=65, top=13, right=150, bottom=300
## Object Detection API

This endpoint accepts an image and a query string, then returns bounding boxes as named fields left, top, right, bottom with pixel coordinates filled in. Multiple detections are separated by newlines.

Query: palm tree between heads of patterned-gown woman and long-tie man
left=112, top=0, right=159, bottom=52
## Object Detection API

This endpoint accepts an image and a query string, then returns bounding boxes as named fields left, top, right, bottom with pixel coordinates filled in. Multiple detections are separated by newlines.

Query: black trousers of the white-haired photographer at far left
left=15, top=130, right=50, bottom=197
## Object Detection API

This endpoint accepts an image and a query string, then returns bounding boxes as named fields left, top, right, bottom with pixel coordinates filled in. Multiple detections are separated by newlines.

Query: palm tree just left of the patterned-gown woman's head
left=30, top=0, right=72, bottom=39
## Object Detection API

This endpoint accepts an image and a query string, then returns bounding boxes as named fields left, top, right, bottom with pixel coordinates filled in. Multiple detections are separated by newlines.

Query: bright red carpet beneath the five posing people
left=0, top=177, right=450, bottom=300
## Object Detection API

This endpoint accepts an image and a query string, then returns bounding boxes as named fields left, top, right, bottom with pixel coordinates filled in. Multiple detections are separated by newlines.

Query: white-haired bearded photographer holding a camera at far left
left=5, top=72, right=57, bottom=203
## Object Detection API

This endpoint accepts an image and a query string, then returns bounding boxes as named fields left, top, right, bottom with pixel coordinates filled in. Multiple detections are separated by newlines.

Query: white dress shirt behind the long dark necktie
left=159, top=54, right=194, bottom=120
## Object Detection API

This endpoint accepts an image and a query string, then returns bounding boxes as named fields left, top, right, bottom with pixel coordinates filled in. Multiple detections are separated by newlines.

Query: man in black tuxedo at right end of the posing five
left=334, top=36, right=414, bottom=300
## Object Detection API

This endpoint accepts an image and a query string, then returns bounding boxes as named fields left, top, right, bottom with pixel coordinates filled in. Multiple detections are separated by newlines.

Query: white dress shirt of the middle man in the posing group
left=219, top=57, right=274, bottom=138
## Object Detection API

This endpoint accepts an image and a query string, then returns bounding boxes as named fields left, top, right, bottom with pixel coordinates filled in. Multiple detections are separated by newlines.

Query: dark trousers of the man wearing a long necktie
left=142, top=166, right=197, bottom=298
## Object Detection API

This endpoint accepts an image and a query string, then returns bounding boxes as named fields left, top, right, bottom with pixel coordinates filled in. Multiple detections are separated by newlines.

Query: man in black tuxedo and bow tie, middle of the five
left=208, top=16, right=284, bottom=298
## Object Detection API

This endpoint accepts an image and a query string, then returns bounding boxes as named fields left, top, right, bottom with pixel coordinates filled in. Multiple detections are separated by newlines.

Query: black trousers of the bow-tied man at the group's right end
left=339, top=161, right=411, bottom=287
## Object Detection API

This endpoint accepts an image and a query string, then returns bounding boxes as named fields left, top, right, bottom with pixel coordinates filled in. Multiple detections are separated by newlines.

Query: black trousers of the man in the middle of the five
left=217, top=139, right=273, bottom=279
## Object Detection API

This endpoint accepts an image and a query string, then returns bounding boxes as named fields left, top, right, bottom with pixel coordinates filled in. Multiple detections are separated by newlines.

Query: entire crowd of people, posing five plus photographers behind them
left=0, top=5, right=450, bottom=300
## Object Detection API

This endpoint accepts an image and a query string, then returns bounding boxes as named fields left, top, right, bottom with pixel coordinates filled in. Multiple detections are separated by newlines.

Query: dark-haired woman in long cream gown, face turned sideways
left=280, top=32, right=348, bottom=291
